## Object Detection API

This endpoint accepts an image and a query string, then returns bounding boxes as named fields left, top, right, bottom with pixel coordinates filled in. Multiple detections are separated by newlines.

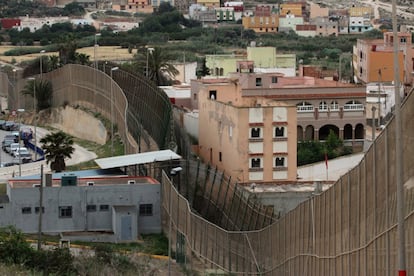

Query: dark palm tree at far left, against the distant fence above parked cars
left=20, top=79, right=53, bottom=111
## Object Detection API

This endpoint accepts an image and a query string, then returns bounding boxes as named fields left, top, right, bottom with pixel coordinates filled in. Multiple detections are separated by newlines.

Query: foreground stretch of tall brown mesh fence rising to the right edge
left=162, top=90, right=414, bottom=276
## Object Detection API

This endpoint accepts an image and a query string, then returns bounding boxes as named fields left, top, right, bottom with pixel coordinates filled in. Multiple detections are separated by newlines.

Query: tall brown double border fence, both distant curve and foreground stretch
left=4, top=65, right=414, bottom=276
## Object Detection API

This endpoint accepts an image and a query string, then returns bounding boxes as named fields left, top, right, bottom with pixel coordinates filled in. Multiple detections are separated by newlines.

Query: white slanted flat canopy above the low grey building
left=95, top=150, right=181, bottom=169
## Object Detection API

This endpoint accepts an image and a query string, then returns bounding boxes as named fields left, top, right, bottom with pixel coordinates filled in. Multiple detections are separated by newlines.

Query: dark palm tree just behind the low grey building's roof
left=40, top=130, right=75, bottom=172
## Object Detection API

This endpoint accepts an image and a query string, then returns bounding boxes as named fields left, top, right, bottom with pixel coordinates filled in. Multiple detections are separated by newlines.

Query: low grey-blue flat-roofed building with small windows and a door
left=0, top=175, right=161, bottom=242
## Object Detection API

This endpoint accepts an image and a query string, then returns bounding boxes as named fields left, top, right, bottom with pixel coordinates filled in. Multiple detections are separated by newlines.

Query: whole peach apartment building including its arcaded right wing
left=191, top=61, right=366, bottom=183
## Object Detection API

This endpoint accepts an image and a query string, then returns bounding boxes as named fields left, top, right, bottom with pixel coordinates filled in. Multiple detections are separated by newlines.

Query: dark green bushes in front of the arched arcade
left=297, top=130, right=352, bottom=166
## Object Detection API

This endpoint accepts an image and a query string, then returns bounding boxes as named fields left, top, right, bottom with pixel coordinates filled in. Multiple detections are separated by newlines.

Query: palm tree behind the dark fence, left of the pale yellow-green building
left=134, top=47, right=179, bottom=85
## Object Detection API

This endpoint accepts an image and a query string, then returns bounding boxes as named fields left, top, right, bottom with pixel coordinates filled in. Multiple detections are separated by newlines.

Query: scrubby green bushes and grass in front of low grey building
left=0, top=226, right=178, bottom=276
